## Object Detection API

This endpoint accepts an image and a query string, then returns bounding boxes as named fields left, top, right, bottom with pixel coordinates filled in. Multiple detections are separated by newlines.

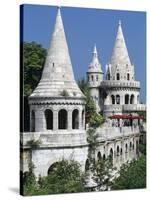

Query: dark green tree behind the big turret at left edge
left=23, top=42, right=46, bottom=96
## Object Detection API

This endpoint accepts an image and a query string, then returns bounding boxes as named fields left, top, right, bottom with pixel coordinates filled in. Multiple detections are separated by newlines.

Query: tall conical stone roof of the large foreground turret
left=31, top=8, right=83, bottom=97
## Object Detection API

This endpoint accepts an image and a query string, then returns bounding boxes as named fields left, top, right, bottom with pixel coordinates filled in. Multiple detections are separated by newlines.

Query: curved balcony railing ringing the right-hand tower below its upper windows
left=100, top=80, right=140, bottom=88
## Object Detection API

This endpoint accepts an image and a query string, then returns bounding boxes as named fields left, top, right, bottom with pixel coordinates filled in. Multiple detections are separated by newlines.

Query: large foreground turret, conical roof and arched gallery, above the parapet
left=29, top=8, right=85, bottom=134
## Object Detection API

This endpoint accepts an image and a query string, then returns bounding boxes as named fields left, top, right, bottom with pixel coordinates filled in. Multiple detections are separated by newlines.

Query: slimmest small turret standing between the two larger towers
left=87, top=45, right=103, bottom=112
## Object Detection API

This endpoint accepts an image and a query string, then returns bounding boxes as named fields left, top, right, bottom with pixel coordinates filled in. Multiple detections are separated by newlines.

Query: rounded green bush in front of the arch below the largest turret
left=39, top=160, right=84, bottom=194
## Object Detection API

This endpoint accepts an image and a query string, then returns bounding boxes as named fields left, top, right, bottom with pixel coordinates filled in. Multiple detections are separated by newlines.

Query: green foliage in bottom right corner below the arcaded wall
left=112, top=155, right=146, bottom=190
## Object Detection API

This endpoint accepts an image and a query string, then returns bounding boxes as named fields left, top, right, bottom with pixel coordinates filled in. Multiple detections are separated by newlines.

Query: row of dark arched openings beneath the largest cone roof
left=31, top=109, right=85, bottom=132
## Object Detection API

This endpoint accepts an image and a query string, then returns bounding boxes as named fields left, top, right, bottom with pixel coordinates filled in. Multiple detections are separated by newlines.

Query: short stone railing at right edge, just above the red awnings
left=123, top=104, right=146, bottom=111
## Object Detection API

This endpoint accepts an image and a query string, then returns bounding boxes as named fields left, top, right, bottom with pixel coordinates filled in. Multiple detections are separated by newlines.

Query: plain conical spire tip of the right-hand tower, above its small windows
left=110, top=20, right=131, bottom=65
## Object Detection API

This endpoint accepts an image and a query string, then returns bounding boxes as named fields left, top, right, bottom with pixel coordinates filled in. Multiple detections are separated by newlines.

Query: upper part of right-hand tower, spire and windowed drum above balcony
left=106, top=21, right=134, bottom=81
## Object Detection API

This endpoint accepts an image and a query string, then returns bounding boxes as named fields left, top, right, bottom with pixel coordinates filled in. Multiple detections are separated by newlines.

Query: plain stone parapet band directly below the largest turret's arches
left=21, top=130, right=87, bottom=148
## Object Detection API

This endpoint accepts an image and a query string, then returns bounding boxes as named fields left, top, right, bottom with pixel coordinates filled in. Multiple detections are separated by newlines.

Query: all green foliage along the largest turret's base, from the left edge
left=24, top=160, right=85, bottom=195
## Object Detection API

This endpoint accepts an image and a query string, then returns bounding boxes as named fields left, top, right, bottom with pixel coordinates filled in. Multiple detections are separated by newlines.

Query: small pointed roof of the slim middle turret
left=88, top=44, right=102, bottom=72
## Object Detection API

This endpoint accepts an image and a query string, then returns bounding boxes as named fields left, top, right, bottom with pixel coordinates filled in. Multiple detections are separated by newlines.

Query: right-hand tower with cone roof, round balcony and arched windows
left=101, top=21, right=140, bottom=115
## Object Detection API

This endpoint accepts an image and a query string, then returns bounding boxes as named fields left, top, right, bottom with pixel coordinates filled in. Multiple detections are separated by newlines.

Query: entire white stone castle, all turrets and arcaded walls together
left=21, top=9, right=145, bottom=177
